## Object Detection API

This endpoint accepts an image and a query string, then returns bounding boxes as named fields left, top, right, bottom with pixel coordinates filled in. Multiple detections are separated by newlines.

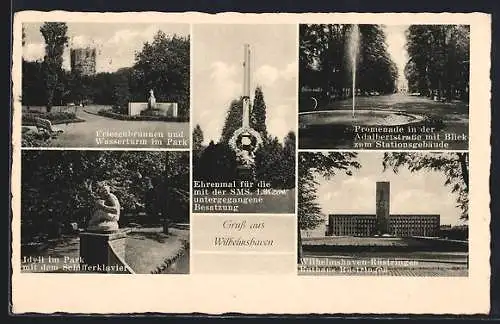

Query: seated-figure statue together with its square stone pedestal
left=80, top=181, right=128, bottom=273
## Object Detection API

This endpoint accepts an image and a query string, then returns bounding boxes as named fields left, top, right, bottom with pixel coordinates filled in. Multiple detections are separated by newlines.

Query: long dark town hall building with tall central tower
left=326, top=182, right=440, bottom=237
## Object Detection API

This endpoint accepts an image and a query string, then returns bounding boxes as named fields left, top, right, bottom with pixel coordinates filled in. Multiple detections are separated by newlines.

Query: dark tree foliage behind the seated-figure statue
left=21, top=151, right=189, bottom=242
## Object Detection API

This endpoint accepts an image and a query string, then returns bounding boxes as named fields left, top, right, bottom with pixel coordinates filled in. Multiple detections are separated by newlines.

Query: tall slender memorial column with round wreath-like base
left=229, top=44, right=262, bottom=181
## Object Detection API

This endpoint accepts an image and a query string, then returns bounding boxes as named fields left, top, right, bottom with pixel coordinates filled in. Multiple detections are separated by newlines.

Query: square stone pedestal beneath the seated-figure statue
left=80, top=229, right=129, bottom=273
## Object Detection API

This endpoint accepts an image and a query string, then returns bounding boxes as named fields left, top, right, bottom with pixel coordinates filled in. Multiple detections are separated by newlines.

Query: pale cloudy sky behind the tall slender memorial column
left=192, top=25, right=298, bottom=144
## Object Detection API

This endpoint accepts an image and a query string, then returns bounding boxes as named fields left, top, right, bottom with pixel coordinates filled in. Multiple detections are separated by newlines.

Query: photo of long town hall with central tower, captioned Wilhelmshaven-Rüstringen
left=297, top=151, right=469, bottom=277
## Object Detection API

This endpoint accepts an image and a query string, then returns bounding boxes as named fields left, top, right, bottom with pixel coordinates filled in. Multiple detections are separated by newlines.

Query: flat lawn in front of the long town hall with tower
left=298, top=237, right=468, bottom=277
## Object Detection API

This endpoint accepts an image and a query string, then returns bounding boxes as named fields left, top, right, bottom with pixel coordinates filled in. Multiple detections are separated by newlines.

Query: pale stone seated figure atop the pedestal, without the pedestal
left=87, top=182, right=120, bottom=232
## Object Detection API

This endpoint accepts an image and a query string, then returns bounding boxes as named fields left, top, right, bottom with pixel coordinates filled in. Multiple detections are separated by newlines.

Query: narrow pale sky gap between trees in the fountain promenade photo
left=384, top=25, right=409, bottom=89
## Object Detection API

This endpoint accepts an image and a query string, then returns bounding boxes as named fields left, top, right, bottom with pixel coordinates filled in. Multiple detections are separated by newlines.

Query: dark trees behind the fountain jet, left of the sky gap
left=299, top=24, right=398, bottom=110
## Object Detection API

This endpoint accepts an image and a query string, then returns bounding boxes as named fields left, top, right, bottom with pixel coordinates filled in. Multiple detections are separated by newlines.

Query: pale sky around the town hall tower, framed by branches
left=306, top=152, right=462, bottom=235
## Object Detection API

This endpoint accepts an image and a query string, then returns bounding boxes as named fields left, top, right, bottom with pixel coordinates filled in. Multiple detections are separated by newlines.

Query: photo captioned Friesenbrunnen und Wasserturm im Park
left=19, top=22, right=190, bottom=149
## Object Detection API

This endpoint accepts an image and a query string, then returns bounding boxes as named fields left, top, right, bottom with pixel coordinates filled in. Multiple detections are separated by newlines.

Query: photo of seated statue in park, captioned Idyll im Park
left=20, top=150, right=190, bottom=274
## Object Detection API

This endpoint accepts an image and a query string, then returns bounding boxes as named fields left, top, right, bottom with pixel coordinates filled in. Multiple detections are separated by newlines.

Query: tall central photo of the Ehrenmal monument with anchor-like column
left=192, top=24, right=297, bottom=213
